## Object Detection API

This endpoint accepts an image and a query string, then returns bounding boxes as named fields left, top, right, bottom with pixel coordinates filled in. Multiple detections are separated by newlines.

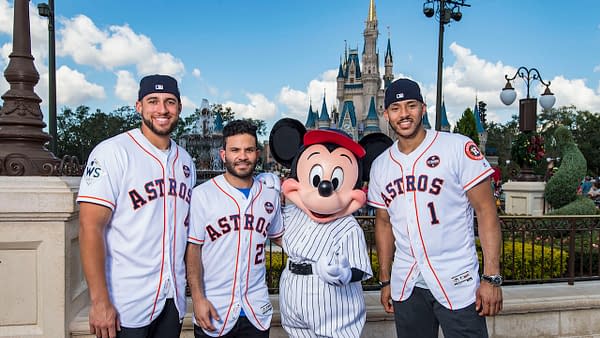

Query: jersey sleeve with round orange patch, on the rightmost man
left=457, top=137, right=494, bottom=191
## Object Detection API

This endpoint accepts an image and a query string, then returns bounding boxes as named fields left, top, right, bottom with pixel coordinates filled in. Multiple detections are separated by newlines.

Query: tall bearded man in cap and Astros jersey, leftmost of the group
left=77, top=75, right=196, bottom=338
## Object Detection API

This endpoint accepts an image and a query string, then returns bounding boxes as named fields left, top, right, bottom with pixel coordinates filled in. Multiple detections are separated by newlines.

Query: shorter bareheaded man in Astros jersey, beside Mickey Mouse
left=186, top=120, right=283, bottom=338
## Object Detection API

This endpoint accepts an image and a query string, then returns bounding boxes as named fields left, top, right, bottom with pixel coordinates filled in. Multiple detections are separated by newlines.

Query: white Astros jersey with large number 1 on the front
left=368, top=131, right=493, bottom=310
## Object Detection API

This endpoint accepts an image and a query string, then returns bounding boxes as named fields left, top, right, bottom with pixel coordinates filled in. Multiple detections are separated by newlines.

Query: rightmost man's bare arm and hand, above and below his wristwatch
left=467, top=178, right=502, bottom=316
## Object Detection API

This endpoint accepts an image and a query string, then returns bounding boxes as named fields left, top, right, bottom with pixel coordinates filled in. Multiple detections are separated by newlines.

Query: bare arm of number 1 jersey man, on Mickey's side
left=375, top=208, right=394, bottom=313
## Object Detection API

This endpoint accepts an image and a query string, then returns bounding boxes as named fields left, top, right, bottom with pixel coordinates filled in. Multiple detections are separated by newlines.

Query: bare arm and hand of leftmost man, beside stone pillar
left=79, top=202, right=121, bottom=338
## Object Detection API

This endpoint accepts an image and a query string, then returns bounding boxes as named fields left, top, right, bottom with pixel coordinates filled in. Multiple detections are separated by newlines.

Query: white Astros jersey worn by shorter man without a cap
left=188, top=175, right=283, bottom=336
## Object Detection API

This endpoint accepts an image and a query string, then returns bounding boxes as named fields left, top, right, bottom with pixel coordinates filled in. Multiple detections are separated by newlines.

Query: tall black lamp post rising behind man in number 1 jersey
left=423, top=0, right=471, bottom=130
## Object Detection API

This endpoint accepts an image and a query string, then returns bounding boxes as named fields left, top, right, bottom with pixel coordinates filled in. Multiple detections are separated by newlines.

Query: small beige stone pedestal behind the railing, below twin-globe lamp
left=502, top=181, right=546, bottom=216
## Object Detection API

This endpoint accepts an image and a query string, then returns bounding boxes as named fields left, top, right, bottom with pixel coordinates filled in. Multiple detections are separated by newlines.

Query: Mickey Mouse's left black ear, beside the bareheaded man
left=269, top=118, right=306, bottom=168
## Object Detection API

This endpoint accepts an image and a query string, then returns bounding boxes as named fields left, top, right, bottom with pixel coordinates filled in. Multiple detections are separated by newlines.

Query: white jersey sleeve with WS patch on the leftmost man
left=77, top=142, right=127, bottom=211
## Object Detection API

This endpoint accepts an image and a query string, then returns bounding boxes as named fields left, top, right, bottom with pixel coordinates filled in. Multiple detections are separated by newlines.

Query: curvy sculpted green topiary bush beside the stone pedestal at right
left=544, top=126, right=587, bottom=209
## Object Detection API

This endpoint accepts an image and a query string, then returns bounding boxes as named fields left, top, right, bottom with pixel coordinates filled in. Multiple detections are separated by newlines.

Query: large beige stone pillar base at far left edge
left=0, top=176, right=89, bottom=338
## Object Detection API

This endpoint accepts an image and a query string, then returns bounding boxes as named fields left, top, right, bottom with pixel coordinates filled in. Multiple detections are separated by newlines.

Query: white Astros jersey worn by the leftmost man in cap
left=77, top=129, right=196, bottom=328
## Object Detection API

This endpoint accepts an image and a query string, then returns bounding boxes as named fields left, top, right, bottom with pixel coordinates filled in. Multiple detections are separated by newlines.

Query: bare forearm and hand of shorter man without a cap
left=185, top=243, right=221, bottom=331
